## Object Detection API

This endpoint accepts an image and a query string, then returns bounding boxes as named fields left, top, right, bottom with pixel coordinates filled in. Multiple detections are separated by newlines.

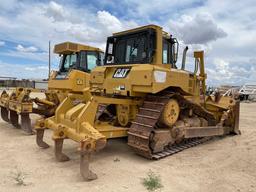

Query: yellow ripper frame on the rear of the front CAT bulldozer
left=39, top=89, right=142, bottom=150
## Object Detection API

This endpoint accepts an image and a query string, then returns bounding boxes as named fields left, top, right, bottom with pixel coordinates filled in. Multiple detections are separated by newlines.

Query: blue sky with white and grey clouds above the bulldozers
left=0, top=0, right=256, bottom=85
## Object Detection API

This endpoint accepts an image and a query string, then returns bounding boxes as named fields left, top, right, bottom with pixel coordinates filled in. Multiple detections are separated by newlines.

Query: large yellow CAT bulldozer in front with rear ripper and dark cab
left=37, top=25, right=240, bottom=180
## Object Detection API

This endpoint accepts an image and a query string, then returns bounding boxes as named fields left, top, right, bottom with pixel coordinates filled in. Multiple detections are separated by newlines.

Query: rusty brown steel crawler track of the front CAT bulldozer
left=128, top=92, right=215, bottom=160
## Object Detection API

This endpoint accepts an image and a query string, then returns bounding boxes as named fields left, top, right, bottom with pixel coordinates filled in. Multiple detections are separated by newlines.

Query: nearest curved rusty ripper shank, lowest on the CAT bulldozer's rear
left=80, top=152, right=98, bottom=181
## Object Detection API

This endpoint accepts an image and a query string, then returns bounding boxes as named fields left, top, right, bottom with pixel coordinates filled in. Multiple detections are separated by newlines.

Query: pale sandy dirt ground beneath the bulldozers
left=0, top=94, right=256, bottom=192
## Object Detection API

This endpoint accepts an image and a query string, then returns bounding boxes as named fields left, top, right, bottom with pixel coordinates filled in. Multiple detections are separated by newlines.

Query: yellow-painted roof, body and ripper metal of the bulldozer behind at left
left=0, top=42, right=103, bottom=134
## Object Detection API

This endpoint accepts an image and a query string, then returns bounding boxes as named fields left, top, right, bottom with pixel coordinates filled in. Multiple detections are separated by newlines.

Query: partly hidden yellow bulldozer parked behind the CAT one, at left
left=0, top=42, right=103, bottom=134
